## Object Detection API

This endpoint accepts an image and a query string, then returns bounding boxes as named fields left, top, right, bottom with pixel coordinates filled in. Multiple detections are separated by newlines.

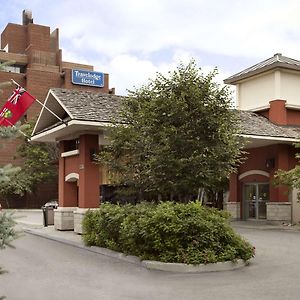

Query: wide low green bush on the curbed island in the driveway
left=83, top=202, right=254, bottom=264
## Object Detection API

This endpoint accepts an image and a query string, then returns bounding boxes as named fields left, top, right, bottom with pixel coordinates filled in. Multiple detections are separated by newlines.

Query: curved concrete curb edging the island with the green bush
left=24, top=229, right=250, bottom=273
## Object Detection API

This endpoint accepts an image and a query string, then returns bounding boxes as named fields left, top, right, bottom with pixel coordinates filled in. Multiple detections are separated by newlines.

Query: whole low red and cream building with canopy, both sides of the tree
left=32, top=54, right=300, bottom=233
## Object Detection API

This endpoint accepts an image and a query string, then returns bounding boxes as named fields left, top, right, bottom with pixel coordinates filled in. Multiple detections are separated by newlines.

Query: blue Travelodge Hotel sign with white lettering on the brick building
left=72, top=70, right=104, bottom=87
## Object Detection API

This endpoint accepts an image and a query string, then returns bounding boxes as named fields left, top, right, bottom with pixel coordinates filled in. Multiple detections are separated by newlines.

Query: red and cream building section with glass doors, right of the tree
left=224, top=53, right=300, bottom=223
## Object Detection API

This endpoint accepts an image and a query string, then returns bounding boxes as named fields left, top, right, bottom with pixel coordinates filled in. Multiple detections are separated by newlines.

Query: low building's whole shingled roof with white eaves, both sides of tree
left=33, top=88, right=300, bottom=142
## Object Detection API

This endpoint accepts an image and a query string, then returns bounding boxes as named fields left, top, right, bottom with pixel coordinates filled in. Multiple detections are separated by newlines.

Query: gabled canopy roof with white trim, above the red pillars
left=31, top=88, right=124, bottom=142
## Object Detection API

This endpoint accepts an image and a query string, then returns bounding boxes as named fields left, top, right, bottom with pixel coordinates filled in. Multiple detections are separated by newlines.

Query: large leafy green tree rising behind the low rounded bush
left=98, top=61, right=241, bottom=200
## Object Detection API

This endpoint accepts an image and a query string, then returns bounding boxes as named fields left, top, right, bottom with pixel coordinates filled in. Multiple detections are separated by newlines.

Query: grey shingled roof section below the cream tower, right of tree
left=238, top=111, right=300, bottom=139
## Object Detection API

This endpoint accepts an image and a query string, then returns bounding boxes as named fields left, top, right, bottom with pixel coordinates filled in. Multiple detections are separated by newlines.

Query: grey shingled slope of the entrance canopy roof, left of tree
left=51, top=88, right=124, bottom=122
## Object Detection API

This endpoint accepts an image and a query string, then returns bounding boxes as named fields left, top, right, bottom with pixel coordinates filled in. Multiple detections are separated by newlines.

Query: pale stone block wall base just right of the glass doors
left=267, top=202, right=292, bottom=222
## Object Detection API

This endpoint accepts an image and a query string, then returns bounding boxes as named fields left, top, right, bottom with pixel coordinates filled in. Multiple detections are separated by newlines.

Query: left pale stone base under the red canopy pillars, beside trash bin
left=54, top=207, right=77, bottom=230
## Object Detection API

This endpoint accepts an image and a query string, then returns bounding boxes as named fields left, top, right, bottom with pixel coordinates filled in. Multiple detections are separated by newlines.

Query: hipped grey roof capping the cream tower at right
left=224, top=53, right=300, bottom=84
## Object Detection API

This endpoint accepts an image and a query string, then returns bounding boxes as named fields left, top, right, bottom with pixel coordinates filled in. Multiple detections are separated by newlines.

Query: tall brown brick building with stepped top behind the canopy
left=0, top=10, right=114, bottom=207
